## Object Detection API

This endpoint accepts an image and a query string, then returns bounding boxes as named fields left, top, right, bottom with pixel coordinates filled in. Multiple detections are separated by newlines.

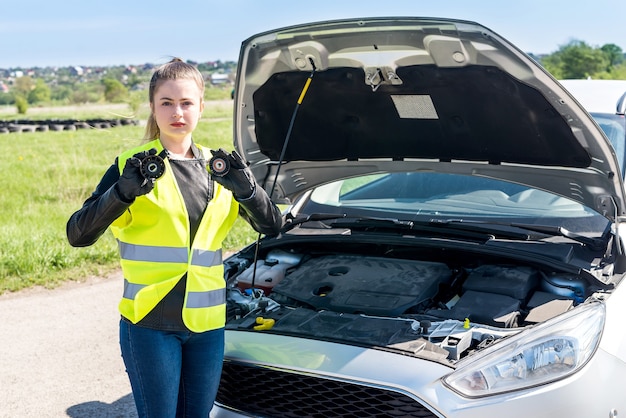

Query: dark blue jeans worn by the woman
left=120, top=320, right=224, bottom=418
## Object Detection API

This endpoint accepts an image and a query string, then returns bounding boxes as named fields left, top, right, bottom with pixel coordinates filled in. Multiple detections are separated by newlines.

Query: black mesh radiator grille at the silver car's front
left=217, top=361, right=437, bottom=418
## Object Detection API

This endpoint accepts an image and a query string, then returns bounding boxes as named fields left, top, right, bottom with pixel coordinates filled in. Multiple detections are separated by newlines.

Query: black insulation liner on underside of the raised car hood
left=254, top=65, right=591, bottom=168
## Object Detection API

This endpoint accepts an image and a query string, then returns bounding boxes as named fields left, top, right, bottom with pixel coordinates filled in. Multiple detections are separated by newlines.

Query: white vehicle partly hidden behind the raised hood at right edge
left=559, top=79, right=626, bottom=177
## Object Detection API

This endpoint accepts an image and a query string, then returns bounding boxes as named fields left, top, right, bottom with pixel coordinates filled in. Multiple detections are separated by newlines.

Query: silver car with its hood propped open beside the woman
left=211, top=17, right=626, bottom=418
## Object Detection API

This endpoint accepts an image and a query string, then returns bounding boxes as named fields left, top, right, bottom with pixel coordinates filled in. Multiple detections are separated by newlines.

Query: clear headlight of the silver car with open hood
left=443, top=303, right=606, bottom=398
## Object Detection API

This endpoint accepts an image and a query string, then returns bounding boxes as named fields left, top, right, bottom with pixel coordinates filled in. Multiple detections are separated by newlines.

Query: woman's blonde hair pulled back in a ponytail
left=143, top=58, right=204, bottom=141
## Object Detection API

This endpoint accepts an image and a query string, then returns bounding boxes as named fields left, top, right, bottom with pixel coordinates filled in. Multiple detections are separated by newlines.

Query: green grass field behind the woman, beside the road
left=0, top=101, right=256, bottom=294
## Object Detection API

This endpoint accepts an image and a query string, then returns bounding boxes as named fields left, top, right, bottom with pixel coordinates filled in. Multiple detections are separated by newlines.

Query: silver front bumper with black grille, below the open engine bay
left=211, top=332, right=626, bottom=418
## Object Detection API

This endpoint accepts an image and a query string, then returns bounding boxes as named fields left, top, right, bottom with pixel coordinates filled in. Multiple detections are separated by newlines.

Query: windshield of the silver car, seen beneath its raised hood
left=305, top=172, right=608, bottom=232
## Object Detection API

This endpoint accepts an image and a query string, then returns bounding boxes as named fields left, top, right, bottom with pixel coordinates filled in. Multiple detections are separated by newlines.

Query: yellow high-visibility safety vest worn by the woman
left=111, top=139, right=239, bottom=332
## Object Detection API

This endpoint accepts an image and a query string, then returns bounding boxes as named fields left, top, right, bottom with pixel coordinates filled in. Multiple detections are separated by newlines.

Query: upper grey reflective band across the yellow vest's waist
left=118, top=241, right=222, bottom=267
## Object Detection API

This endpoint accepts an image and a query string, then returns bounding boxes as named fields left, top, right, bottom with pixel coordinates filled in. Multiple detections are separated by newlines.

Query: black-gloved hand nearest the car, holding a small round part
left=209, top=148, right=256, bottom=200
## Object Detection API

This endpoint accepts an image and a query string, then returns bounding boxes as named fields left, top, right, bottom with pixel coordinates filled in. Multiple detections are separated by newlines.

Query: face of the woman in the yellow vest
left=151, top=79, right=204, bottom=142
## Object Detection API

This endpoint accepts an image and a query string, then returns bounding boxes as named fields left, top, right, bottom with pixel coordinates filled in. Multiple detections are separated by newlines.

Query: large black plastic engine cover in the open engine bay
left=272, top=255, right=452, bottom=316
